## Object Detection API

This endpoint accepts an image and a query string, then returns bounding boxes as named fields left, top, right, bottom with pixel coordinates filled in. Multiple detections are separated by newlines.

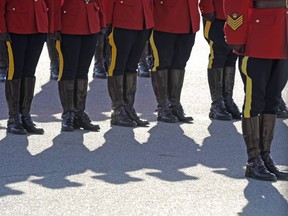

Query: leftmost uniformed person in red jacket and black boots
left=0, top=0, right=60, bottom=134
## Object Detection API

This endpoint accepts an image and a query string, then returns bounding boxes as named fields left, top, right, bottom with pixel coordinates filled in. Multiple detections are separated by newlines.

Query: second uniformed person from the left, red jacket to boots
left=56, top=0, right=105, bottom=131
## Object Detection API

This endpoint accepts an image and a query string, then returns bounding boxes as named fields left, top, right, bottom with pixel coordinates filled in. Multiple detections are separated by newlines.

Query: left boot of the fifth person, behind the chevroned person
left=208, top=68, right=232, bottom=120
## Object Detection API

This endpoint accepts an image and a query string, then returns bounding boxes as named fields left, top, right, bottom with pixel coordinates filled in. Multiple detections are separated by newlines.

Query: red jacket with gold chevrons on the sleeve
left=224, top=0, right=288, bottom=59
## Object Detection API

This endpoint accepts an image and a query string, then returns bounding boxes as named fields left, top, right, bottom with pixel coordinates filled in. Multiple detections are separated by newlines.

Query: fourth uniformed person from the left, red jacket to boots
left=150, top=0, right=200, bottom=123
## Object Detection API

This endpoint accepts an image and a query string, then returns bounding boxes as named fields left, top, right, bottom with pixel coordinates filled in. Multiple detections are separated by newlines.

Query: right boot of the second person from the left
left=73, top=79, right=100, bottom=131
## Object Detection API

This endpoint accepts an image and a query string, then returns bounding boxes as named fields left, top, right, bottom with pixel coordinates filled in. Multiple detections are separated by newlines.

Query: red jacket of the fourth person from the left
left=153, top=0, right=200, bottom=33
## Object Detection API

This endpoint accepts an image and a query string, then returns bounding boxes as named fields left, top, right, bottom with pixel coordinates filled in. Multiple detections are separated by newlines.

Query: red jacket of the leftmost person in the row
left=0, top=0, right=61, bottom=34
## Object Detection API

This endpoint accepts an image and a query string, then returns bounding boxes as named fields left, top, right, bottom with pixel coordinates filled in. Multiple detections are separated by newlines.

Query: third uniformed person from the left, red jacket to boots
left=105, top=0, right=154, bottom=127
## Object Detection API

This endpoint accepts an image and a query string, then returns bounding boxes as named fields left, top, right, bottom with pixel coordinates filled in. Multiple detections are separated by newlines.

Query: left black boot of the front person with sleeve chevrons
left=242, top=116, right=277, bottom=181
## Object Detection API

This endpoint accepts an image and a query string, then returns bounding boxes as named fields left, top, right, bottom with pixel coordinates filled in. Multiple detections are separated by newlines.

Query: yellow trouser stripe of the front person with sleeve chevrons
left=241, top=56, right=252, bottom=118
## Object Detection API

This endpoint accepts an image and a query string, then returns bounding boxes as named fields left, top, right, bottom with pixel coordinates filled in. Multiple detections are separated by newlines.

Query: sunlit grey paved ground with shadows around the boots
left=0, top=33, right=288, bottom=216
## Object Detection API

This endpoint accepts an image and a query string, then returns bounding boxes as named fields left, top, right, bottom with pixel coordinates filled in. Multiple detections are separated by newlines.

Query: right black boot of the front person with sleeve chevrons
left=259, top=114, right=288, bottom=180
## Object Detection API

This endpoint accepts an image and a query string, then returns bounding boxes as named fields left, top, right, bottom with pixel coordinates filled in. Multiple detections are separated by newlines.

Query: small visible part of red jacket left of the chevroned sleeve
left=199, top=0, right=225, bottom=20
